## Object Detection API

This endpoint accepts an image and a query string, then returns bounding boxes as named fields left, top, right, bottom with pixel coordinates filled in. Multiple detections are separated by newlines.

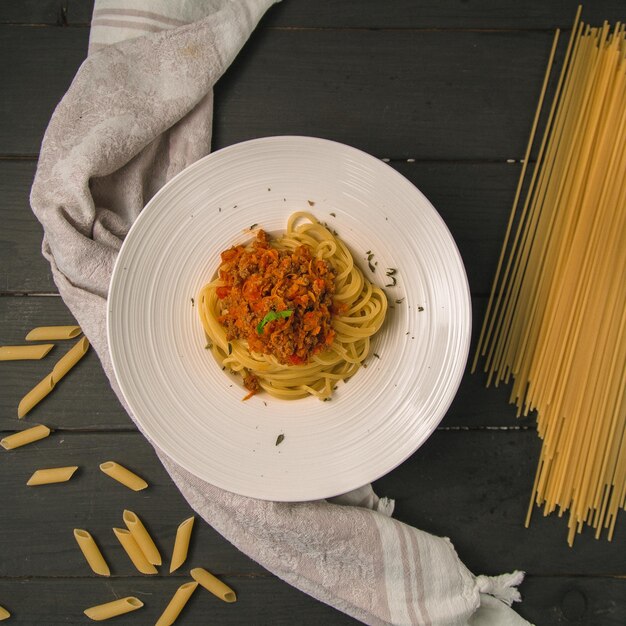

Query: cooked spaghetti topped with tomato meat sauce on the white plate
left=198, top=212, right=387, bottom=400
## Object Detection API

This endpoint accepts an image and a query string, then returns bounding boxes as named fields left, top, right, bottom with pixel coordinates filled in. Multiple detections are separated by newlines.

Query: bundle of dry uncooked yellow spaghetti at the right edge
left=474, top=9, right=626, bottom=545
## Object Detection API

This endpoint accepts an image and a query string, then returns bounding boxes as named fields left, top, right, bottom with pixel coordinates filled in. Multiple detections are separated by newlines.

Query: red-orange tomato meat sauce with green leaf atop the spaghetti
left=216, top=230, right=345, bottom=393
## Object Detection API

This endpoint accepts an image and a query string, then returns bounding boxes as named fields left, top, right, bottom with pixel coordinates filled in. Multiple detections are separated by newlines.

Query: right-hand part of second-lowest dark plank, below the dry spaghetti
left=375, top=430, right=626, bottom=576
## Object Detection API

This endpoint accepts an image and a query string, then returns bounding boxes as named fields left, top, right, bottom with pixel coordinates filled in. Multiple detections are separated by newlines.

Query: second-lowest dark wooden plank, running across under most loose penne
left=0, top=430, right=626, bottom=578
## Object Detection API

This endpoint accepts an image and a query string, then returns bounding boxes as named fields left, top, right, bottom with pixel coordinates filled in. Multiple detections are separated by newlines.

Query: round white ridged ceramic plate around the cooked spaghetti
left=108, top=137, right=471, bottom=501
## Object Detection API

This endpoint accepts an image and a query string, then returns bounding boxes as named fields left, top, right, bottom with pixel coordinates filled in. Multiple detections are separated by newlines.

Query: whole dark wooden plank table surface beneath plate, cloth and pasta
left=0, top=0, right=626, bottom=626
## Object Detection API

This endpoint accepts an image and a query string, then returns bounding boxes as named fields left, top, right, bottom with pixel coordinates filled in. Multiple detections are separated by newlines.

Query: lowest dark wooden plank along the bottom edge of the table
left=0, top=576, right=626, bottom=626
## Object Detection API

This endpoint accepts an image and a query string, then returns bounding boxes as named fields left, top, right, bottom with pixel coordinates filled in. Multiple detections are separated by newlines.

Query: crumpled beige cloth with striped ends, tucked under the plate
left=31, top=0, right=527, bottom=626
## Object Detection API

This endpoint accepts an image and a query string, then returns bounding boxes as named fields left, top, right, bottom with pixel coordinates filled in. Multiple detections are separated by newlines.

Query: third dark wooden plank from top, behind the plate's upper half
left=0, top=161, right=520, bottom=295
